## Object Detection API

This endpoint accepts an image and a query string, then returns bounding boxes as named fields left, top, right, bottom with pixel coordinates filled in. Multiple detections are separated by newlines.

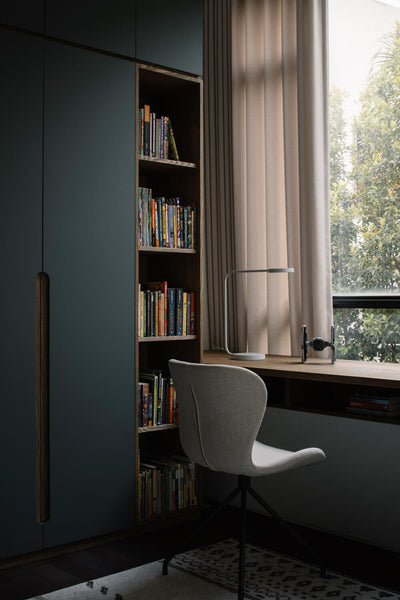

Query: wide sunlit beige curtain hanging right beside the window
left=206, top=0, right=332, bottom=355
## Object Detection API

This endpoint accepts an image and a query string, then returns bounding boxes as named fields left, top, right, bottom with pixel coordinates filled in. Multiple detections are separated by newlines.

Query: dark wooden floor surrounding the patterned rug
left=0, top=509, right=400, bottom=600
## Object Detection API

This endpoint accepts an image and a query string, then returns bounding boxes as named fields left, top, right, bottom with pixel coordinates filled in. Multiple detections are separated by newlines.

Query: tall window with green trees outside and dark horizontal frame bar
left=329, top=0, right=400, bottom=362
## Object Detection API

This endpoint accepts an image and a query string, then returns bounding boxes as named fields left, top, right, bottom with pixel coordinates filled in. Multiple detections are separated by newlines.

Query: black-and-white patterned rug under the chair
left=30, top=539, right=400, bottom=600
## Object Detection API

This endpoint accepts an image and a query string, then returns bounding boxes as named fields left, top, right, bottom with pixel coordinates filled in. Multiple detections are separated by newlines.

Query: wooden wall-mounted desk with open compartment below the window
left=202, top=351, right=400, bottom=425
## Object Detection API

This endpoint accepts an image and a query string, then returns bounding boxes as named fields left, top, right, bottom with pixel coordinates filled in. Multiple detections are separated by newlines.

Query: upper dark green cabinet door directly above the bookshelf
left=136, top=0, right=203, bottom=75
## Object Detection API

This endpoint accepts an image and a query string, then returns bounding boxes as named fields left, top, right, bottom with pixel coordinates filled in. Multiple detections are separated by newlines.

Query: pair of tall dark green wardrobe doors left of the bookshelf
left=0, top=30, right=136, bottom=556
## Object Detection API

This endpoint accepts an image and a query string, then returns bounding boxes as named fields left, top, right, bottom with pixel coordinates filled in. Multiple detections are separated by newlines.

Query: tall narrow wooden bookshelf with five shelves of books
left=135, top=64, right=203, bottom=527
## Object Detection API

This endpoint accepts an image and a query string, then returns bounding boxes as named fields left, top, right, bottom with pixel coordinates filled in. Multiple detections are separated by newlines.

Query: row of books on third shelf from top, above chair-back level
left=138, top=281, right=195, bottom=337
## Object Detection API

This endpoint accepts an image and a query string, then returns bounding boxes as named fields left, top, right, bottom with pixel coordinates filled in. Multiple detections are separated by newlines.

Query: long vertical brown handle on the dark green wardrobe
left=35, top=273, right=50, bottom=523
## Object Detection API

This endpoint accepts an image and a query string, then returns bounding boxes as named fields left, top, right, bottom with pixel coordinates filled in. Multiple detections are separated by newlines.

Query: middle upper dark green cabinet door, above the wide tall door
left=46, top=0, right=135, bottom=57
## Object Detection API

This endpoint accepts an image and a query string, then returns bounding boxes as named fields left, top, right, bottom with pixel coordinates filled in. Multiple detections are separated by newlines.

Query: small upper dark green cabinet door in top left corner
left=0, top=0, right=44, bottom=33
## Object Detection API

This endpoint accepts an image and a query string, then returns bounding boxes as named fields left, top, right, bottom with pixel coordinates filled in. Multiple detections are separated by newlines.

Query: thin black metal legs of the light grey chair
left=162, top=475, right=326, bottom=600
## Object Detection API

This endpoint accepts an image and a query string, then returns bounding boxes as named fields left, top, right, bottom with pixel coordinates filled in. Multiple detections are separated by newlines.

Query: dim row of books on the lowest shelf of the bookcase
left=139, top=456, right=198, bottom=519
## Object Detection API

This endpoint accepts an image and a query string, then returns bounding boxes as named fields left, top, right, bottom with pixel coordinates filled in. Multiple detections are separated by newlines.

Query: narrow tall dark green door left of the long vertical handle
left=0, top=31, right=43, bottom=557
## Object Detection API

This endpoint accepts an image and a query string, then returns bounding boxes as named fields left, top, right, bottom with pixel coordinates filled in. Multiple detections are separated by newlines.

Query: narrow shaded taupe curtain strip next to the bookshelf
left=204, top=0, right=238, bottom=348
